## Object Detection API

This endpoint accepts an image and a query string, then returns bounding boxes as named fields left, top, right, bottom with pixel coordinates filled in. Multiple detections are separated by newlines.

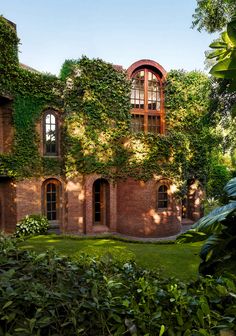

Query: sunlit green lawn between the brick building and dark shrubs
left=21, top=235, right=201, bottom=281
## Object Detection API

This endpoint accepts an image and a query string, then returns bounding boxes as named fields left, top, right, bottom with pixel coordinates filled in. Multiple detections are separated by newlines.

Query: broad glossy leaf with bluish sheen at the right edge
left=192, top=201, right=236, bottom=235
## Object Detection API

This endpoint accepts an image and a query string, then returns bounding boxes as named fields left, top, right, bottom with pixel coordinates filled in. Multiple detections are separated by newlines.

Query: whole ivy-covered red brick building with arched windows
left=0, top=17, right=215, bottom=237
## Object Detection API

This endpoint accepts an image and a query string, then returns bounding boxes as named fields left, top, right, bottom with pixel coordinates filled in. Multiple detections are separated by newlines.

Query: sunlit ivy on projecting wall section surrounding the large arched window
left=65, top=62, right=217, bottom=184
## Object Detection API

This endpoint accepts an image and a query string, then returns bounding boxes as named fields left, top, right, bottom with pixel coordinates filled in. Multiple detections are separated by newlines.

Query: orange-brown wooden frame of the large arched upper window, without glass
left=131, top=67, right=165, bottom=134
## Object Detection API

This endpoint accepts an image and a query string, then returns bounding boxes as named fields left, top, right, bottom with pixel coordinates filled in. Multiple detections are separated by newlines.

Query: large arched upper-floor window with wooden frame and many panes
left=131, top=68, right=163, bottom=133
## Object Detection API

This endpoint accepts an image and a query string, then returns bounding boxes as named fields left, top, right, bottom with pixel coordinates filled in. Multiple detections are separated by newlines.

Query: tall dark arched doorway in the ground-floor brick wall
left=93, top=178, right=110, bottom=226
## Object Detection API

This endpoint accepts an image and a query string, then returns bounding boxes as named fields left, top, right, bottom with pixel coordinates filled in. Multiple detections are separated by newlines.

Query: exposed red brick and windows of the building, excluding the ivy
left=0, top=17, right=202, bottom=237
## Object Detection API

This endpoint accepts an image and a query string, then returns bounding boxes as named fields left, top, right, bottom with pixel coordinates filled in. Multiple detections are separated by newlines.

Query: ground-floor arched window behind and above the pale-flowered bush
left=43, top=179, right=60, bottom=221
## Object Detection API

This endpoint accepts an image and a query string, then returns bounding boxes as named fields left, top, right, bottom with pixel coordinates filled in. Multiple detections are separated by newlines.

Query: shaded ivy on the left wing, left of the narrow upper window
left=0, top=17, right=62, bottom=178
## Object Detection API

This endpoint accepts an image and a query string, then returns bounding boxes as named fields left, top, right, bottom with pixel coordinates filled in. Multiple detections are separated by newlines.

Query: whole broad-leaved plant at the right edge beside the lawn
left=177, top=178, right=236, bottom=274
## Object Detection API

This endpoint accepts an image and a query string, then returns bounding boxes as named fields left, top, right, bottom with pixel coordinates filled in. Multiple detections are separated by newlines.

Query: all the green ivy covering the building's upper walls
left=0, top=17, right=219, bottom=193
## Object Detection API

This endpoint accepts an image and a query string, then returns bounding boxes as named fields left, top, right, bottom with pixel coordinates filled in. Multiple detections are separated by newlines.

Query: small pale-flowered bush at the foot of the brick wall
left=15, top=215, right=49, bottom=237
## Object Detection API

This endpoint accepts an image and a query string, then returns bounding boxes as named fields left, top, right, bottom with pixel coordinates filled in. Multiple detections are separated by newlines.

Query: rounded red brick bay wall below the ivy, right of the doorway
left=117, top=179, right=181, bottom=237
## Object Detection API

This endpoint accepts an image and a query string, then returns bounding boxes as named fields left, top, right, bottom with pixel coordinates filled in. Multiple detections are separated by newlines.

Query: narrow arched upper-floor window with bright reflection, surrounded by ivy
left=43, top=112, right=58, bottom=156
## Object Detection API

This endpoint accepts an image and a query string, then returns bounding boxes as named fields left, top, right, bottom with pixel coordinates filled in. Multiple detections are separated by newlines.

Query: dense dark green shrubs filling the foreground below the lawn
left=0, top=238, right=236, bottom=336
